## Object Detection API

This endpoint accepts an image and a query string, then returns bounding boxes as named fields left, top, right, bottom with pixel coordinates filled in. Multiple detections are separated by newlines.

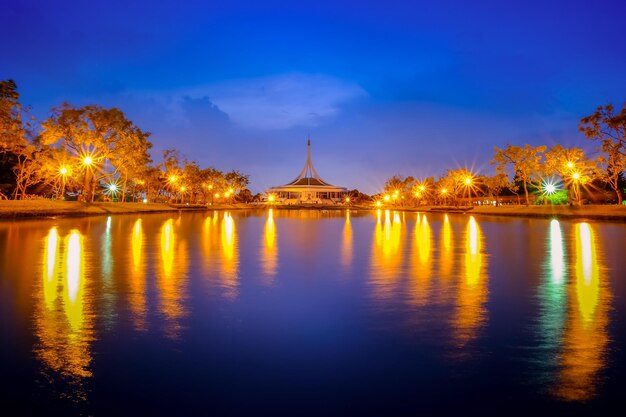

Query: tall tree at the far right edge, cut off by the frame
left=578, top=103, right=626, bottom=204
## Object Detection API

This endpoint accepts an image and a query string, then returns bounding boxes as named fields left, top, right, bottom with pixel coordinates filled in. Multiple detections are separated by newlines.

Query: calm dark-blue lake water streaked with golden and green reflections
left=0, top=210, right=626, bottom=416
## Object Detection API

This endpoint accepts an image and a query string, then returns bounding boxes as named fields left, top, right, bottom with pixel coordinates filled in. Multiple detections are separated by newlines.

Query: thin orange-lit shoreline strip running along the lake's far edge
left=0, top=200, right=626, bottom=222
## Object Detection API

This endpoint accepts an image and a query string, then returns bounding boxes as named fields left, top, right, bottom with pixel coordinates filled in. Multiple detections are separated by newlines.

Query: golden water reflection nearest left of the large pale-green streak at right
left=453, top=216, right=487, bottom=347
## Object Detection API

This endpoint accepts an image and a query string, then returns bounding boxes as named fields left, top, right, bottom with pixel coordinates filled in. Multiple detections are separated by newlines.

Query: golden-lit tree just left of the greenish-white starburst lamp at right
left=491, top=144, right=546, bottom=205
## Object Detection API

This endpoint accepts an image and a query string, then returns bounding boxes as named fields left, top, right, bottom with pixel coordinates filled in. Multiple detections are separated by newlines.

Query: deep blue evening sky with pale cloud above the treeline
left=0, top=0, right=626, bottom=193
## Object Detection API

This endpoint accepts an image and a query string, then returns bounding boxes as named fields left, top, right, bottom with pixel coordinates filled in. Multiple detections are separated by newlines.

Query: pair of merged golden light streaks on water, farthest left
left=34, top=224, right=93, bottom=386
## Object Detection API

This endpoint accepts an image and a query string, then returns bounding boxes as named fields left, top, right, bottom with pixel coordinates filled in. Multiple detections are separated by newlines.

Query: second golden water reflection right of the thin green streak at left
left=158, top=219, right=187, bottom=338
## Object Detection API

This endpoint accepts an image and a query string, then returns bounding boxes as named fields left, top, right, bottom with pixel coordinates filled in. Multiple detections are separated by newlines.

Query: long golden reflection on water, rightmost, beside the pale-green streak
left=555, top=223, right=611, bottom=401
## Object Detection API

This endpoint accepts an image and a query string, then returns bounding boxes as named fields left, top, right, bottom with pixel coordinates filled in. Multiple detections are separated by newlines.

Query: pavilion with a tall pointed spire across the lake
left=267, top=139, right=348, bottom=204
